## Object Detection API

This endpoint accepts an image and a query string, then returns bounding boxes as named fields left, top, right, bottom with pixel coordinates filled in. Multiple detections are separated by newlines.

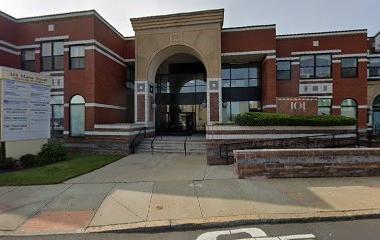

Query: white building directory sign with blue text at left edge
left=0, top=68, right=51, bottom=142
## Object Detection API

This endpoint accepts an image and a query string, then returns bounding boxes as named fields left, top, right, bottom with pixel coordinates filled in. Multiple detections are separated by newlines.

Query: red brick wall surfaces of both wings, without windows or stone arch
left=0, top=8, right=374, bottom=136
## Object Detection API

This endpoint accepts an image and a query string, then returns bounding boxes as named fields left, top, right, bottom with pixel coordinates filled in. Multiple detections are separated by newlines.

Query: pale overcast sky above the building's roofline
left=0, top=0, right=380, bottom=36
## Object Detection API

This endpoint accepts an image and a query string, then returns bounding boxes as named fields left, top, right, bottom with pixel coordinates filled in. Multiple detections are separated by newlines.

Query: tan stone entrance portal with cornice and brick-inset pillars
left=131, top=10, right=223, bottom=130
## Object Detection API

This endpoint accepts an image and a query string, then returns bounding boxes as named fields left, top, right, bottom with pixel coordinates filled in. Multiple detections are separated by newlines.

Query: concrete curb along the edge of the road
left=85, top=209, right=380, bottom=233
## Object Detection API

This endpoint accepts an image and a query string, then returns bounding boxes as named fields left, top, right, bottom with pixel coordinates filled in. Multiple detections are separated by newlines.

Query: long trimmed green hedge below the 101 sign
left=235, top=112, right=357, bottom=126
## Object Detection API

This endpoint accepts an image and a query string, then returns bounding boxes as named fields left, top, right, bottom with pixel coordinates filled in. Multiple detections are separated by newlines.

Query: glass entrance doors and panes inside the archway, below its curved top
left=156, top=71, right=207, bottom=134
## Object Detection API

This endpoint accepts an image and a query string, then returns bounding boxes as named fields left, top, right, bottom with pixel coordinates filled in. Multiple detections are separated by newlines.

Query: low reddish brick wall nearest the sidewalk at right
left=234, top=148, right=380, bottom=178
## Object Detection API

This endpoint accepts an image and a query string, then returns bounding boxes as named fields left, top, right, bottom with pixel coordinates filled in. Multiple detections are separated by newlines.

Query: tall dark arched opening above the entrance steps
left=155, top=53, right=207, bottom=134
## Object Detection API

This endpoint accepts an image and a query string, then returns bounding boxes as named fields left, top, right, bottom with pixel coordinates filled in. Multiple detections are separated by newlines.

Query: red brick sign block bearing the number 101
left=277, top=97, right=318, bottom=116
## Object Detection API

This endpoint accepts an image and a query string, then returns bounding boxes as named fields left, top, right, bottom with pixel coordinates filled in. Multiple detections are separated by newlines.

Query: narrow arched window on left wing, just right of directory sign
left=70, top=95, right=85, bottom=136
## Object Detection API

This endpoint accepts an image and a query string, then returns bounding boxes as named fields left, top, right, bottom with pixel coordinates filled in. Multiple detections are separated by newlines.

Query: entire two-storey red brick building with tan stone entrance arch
left=0, top=9, right=380, bottom=141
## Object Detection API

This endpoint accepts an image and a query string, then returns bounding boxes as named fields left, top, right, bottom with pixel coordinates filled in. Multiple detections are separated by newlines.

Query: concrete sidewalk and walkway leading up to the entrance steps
left=0, top=154, right=380, bottom=234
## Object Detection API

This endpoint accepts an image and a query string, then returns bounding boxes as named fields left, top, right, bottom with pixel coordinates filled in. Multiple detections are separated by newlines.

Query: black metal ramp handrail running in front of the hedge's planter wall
left=219, top=131, right=362, bottom=165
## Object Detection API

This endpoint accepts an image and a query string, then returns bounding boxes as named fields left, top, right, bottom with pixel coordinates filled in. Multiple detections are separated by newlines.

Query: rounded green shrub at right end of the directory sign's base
left=38, top=141, right=67, bottom=165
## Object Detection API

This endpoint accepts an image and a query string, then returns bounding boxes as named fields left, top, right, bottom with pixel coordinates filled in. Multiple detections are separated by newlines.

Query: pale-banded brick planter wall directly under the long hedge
left=206, top=125, right=356, bottom=165
